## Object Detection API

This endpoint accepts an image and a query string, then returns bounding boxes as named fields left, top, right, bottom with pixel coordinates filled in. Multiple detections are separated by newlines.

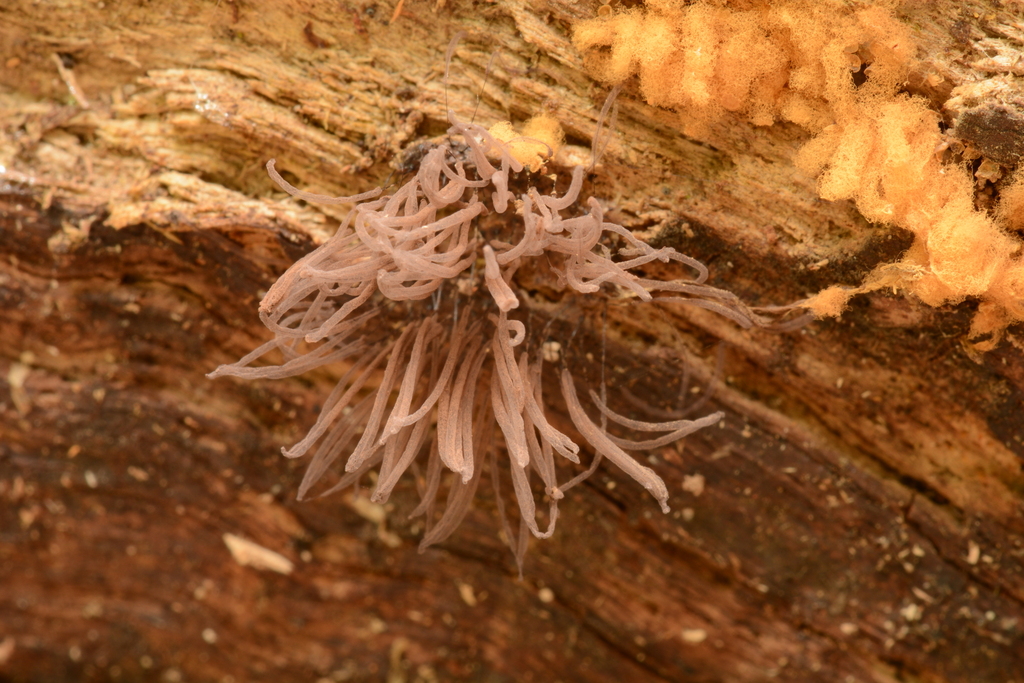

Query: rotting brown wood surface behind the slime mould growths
left=0, top=1, right=1024, bottom=682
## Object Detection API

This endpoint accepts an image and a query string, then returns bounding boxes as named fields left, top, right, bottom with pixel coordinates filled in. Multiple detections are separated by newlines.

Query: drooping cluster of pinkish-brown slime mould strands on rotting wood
left=210, top=93, right=798, bottom=566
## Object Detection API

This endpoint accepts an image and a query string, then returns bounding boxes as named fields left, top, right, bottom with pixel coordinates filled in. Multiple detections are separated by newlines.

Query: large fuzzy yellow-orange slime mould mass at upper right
left=573, top=0, right=1024, bottom=333
